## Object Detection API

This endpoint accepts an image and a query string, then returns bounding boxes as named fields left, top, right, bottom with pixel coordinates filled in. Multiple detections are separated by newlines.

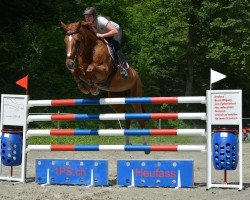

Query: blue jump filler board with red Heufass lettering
left=117, top=160, right=194, bottom=187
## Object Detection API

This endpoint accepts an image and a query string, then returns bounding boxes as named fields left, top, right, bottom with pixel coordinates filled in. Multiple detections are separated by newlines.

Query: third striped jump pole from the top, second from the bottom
left=27, top=129, right=206, bottom=137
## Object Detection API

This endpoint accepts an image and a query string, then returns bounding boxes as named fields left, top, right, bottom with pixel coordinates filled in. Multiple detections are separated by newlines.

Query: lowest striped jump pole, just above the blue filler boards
left=26, top=144, right=206, bottom=151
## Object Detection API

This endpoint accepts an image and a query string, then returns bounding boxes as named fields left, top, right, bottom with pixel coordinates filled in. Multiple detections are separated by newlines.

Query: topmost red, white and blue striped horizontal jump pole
left=28, top=96, right=206, bottom=107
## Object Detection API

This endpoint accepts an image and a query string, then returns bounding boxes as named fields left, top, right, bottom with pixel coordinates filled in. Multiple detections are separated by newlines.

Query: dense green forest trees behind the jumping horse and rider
left=0, top=0, right=250, bottom=132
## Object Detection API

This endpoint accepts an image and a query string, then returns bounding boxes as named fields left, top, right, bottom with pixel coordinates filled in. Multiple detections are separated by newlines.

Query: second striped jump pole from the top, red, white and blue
left=27, top=113, right=206, bottom=122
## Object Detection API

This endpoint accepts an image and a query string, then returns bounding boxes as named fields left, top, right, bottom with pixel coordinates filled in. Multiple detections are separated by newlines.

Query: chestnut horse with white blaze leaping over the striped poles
left=61, top=21, right=147, bottom=144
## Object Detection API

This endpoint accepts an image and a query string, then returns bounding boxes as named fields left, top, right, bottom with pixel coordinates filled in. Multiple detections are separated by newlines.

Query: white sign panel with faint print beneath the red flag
left=1, top=95, right=27, bottom=126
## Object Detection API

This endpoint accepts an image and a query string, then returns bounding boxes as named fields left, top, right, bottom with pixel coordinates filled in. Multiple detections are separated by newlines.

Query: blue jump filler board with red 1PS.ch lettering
left=36, top=159, right=108, bottom=186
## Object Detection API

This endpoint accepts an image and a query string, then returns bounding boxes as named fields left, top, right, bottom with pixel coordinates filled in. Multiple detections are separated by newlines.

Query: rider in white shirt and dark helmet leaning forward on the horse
left=83, top=7, right=128, bottom=78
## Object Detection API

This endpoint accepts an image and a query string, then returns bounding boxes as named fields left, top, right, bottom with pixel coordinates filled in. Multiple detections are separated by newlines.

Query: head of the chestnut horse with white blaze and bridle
left=61, top=21, right=82, bottom=70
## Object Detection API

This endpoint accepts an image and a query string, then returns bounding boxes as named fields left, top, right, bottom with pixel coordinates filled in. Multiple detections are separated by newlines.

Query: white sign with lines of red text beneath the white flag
left=211, top=90, right=242, bottom=125
